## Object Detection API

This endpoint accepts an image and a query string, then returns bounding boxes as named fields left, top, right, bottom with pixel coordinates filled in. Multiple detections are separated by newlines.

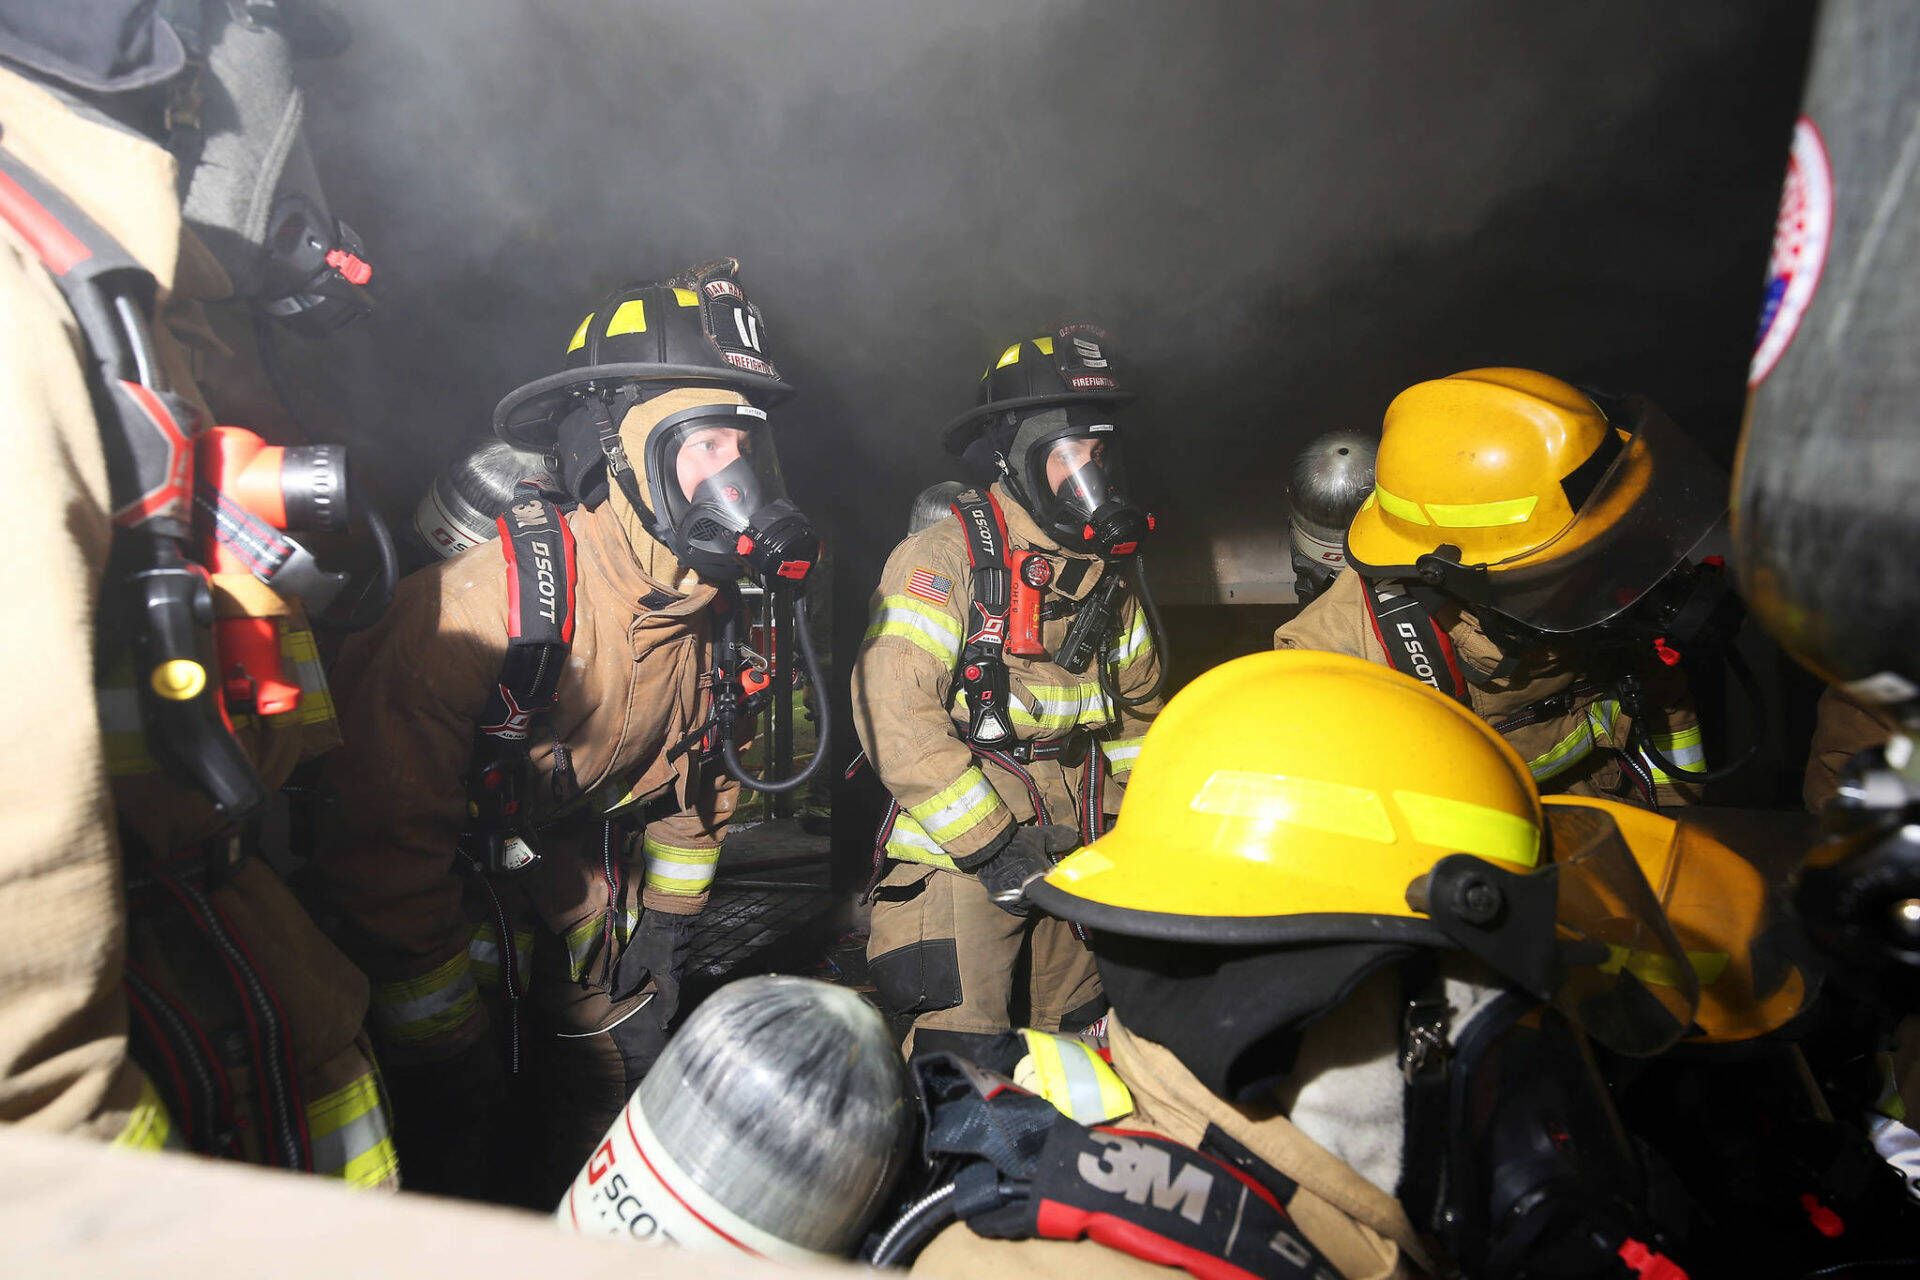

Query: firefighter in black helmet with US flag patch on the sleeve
left=852, top=324, right=1164, bottom=1050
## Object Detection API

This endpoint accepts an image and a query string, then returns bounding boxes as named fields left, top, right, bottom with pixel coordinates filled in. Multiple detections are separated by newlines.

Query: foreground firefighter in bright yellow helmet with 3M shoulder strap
left=876, top=652, right=1704, bottom=1280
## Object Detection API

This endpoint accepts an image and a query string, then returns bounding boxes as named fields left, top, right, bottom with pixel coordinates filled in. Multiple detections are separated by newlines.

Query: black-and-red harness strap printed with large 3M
left=914, top=1054, right=1338, bottom=1280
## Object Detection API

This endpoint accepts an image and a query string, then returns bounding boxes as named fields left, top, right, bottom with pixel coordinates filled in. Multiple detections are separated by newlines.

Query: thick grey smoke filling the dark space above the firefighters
left=291, top=0, right=1809, bottom=602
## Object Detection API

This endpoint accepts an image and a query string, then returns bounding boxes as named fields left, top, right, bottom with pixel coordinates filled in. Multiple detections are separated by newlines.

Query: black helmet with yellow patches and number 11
left=493, top=257, right=793, bottom=453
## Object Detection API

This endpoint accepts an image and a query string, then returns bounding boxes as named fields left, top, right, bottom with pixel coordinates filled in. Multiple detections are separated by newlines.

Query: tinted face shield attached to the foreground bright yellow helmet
left=1413, top=808, right=1699, bottom=1057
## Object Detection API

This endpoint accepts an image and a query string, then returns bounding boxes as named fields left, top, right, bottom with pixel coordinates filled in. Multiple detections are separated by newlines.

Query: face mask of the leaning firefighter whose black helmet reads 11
left=647, top=405, right=820, bottom=585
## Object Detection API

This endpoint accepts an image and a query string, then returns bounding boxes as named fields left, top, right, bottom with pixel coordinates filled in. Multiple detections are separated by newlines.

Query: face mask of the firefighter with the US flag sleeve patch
left=1008, top=405, right=1154, bottom=560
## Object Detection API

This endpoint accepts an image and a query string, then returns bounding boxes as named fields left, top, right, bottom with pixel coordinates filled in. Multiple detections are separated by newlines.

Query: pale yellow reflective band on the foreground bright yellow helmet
left=1188, top=770, right=1540, bottom=867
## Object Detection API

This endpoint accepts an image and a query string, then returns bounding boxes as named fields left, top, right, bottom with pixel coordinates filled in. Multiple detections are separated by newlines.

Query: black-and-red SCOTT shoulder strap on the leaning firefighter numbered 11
left=461, top=480, right=576, bottom=875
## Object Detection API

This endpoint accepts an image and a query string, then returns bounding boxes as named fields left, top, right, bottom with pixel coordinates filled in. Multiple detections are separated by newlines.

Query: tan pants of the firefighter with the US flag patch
left=866, top=862, right=1106, bottom=1055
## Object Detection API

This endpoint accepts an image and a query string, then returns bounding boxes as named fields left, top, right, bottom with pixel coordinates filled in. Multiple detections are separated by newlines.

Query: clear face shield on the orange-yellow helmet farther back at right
left=1413, top=399, right=1728, bottom=633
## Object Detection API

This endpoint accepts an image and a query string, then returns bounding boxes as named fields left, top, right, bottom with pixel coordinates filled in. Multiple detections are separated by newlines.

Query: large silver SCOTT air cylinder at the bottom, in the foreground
left=557, top=977, right=912, bottom=1259
